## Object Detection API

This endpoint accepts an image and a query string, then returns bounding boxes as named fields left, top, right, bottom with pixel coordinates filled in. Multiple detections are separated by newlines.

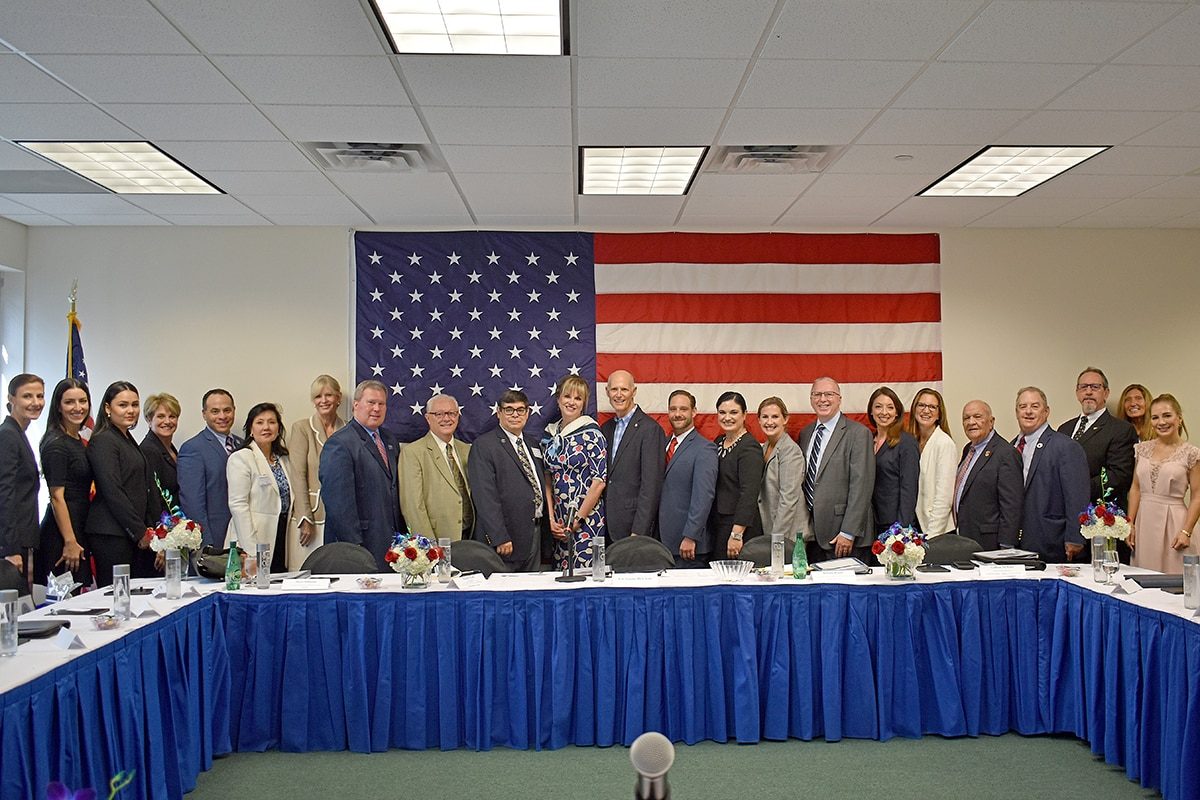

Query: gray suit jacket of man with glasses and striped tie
left=800, top=414, right=875, bottom=551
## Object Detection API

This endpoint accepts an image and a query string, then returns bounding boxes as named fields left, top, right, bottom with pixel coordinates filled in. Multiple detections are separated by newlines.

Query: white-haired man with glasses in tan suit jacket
left=400, top=395, right=475, bottom=540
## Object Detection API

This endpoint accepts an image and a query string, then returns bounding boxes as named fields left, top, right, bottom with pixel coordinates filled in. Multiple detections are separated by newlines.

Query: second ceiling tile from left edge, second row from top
left=38, top=55, right=246, bottom=103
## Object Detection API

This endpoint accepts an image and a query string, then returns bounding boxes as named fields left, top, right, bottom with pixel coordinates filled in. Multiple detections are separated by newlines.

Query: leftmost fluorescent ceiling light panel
left=17, top=142, right=222, bottom=194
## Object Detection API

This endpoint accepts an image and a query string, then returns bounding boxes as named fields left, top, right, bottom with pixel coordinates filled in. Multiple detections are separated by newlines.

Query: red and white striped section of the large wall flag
left=595, top=234, right=942, bottom=437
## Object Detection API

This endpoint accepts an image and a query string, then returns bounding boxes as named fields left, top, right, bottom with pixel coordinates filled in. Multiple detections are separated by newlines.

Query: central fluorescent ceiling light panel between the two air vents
left=580, top=148, right=708, bottom=194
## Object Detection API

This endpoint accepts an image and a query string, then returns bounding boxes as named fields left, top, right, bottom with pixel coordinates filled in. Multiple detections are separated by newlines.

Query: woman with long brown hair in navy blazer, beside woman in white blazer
left=866, top=386, right=920, bottom=535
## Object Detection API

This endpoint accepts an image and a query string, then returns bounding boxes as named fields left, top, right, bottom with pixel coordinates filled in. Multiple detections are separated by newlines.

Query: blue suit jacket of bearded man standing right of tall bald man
left=657, top=429, right=718, bottom=555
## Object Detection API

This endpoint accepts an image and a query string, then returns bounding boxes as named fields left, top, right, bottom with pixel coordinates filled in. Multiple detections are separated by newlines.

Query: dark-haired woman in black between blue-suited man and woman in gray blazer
left=708, top=392, right=764, bottom=560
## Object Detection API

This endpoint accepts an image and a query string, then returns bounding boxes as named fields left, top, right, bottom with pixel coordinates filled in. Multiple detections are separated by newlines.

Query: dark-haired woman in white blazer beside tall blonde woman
left=226, top=403, right=293, bottom=572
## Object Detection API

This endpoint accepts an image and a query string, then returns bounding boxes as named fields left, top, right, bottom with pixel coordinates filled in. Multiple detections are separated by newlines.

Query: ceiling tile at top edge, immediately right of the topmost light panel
left=571, top=0, right=775, bottom=59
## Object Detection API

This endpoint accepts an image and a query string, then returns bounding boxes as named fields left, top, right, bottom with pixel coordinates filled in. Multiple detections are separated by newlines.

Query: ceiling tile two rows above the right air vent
left=739, top=59, right=922, bottom=109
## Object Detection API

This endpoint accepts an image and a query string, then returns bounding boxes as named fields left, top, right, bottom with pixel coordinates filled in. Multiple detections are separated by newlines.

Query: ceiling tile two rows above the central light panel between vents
left=576, top=59, right=748, bottom=108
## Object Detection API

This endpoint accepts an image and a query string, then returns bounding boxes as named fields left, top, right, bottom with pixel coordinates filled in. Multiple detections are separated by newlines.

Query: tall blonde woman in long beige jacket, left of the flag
left=287, top=375, right=346, bottom=570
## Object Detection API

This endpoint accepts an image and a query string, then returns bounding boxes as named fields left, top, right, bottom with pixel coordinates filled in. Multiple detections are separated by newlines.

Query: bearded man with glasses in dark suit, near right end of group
left=1058, top=367, right=1138, bottom=564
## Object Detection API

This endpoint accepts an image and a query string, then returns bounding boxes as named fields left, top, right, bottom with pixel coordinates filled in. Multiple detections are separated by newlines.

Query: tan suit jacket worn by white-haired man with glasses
left=397, top=433, right=470, bottom=540
